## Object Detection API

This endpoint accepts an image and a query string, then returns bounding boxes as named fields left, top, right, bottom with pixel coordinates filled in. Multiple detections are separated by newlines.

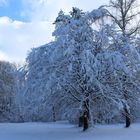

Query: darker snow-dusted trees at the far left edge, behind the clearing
left=0, top=61, right=17, bottom=121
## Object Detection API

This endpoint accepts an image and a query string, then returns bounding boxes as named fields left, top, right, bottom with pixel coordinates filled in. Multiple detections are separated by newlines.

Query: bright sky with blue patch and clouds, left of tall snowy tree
left=0, top=0, right=109, bottom=62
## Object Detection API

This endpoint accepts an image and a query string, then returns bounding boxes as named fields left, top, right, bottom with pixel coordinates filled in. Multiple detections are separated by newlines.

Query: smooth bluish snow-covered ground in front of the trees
left=0, top=122, right=140, bottom=140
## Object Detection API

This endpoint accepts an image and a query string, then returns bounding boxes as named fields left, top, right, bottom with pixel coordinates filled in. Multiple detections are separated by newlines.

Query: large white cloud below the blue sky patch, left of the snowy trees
left=0, top=17, right=53, bottom=61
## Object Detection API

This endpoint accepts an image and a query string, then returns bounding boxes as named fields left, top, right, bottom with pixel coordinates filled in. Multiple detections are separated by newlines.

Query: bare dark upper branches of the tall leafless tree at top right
left=103, top=0, right=140, bottom=37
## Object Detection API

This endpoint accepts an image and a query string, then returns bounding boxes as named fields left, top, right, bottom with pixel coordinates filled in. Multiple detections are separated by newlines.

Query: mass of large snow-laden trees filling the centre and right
left=0, top=0, right=140, bottom=128
